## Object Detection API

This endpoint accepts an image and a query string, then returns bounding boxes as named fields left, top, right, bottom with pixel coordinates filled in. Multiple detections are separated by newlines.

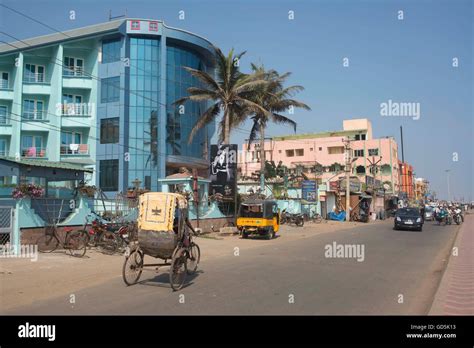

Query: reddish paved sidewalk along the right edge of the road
left=429, top=213, right=474, bottom=315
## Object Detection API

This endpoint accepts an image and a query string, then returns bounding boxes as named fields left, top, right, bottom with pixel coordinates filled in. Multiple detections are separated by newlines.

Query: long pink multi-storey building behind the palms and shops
left=239, top=119, right=400, bottom=195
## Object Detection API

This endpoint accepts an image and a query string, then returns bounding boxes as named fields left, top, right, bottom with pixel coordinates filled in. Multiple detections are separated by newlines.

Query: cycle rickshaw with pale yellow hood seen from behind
left=122, top=192, right=201, bottom=291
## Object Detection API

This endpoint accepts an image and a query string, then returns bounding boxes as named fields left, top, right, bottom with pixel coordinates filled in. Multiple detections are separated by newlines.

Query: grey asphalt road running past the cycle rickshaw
left=8, top=220, right=457, bottom=315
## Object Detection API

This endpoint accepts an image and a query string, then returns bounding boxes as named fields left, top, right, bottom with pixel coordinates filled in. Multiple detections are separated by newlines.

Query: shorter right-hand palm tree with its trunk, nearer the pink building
left=247, top=64, right=311, bottom=181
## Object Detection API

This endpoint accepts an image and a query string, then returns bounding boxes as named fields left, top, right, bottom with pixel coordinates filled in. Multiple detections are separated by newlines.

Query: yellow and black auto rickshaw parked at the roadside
left=237, top=199, right=280, bottom=239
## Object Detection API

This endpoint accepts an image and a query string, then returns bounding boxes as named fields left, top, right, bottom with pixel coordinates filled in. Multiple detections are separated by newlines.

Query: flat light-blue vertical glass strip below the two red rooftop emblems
left=125, top=38, right=161, bottom=190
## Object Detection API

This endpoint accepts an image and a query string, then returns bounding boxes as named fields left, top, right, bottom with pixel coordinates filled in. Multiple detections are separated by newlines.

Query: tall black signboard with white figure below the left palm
left=209, top=144, right=238, bottom=200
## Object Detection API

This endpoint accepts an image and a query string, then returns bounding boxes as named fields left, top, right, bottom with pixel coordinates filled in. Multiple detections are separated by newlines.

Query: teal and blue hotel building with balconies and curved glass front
left=0, top=19, right=215, bottom=196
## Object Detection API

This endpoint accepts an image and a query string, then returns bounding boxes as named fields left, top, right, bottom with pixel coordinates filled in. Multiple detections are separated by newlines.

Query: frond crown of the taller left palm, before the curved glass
left=175, top=47, right=267, bottom=144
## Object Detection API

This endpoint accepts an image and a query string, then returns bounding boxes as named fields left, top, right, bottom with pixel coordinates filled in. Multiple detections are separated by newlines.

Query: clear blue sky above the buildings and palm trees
left=0, top=0, right=474, bottom=200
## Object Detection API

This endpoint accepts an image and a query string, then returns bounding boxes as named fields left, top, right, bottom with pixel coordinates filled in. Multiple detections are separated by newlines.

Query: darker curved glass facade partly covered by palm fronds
left=166, top=45, right=207, bottom=158
